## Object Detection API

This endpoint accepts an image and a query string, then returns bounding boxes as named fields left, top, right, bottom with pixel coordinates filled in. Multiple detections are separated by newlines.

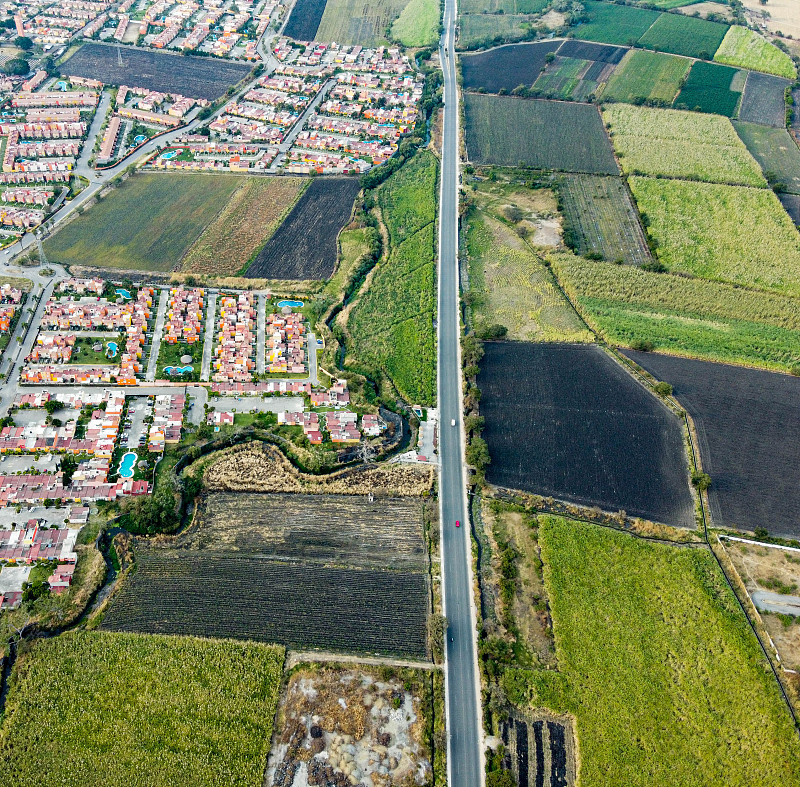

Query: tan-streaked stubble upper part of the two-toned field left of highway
left=194, top=492, right=426, bottom=571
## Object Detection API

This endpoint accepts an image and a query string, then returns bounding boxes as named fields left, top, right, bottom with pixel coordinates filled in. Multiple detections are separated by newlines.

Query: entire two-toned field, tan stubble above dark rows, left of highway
left=104, top=493, right=429, bottom=657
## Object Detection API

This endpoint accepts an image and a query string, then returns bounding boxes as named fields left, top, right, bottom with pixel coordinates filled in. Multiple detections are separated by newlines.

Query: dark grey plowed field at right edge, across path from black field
left=626, top=351, right=800, bottom=538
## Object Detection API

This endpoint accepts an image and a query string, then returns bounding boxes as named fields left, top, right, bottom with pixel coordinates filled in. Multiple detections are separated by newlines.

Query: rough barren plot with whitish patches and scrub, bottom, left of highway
left=266, top=666, right=433, bottom=787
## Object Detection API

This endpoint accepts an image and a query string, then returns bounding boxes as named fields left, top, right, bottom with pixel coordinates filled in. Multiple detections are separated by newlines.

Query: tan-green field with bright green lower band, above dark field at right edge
left=549, top=254, right=800, bottom=371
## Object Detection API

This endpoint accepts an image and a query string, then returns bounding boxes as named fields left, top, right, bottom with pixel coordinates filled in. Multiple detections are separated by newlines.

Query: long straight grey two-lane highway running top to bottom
left=438, top=0, right=484, bottom=787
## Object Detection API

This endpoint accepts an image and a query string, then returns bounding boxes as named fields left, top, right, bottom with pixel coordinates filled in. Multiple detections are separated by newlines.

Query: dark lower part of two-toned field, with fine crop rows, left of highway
left=103, top=550, right=428, bottom=657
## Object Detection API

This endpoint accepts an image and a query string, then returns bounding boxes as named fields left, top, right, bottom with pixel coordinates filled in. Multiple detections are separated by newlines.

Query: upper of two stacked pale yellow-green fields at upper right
left=603, top=104, right=764, bottom=187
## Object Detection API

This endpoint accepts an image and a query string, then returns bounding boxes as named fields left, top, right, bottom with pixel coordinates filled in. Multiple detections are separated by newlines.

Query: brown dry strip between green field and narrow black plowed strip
left=180, top=178, right=309, bottom=276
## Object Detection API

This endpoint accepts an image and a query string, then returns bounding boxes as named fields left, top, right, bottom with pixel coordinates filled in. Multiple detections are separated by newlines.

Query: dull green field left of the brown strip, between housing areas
left=44, top=172, right=242, bottom=271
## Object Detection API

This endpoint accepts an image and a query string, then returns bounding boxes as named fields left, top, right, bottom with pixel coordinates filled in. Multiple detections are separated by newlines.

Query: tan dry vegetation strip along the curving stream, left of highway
left=204, top=443, right=434, bottom=497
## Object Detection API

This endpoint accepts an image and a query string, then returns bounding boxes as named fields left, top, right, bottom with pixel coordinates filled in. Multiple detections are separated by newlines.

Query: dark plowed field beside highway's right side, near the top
left=461, top=41, right=562, bottom=93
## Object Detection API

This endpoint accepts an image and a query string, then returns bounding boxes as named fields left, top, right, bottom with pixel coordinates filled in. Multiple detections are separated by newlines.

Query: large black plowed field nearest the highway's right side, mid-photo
left=478, top=342, right=694, bottom=527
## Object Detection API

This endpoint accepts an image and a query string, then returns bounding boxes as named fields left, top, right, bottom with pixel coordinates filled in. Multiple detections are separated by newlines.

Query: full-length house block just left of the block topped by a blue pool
left=211, top=292, right=256, bottom=382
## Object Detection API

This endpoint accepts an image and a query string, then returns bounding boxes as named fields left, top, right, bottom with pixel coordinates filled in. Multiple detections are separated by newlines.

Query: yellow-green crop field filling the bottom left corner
left=0, top=631, right=284, bottom=787
